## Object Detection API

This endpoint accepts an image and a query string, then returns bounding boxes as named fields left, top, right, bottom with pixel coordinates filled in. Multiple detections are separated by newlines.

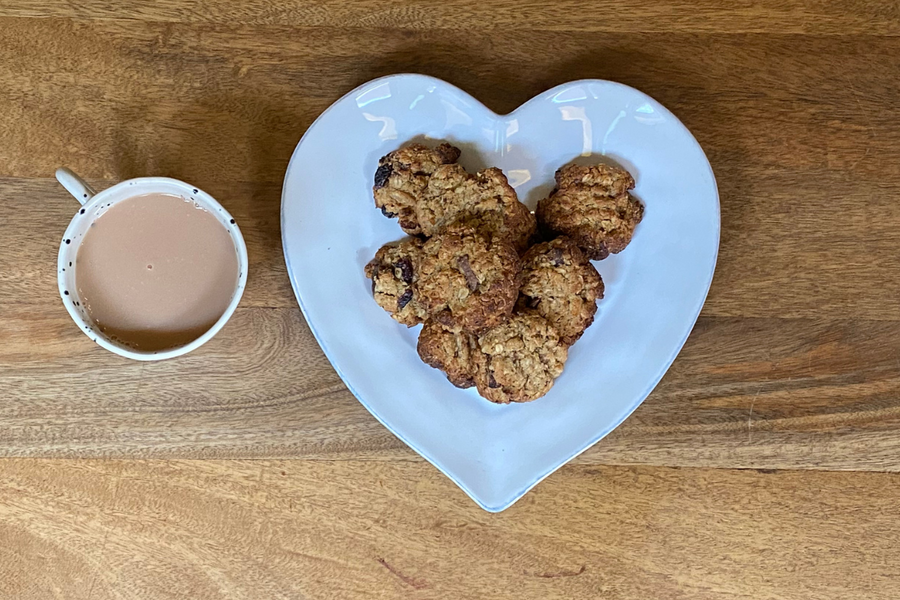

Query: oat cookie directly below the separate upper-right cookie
left=516, top=237, right=603, bottom=346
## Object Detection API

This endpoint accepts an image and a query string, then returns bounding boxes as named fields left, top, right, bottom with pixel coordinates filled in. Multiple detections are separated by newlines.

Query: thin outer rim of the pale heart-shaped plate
left=279, top=72, right=722, bottom=513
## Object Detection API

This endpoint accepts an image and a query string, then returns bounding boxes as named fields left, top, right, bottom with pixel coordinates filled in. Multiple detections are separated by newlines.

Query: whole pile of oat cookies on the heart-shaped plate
left=366, top=144, right=643, bottom=404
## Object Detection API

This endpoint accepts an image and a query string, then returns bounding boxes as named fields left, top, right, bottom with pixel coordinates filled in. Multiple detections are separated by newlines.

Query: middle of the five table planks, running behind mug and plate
left=10, top=169, right=900, bottom=320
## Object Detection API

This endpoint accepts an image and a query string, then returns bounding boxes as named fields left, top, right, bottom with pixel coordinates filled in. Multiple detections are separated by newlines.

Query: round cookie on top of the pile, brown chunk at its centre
left=417, top=225, right=520, bottom=332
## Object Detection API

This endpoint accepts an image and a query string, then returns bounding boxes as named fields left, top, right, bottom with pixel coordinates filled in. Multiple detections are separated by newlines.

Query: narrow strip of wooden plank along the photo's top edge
left=0, top=0, right=900, bottom=35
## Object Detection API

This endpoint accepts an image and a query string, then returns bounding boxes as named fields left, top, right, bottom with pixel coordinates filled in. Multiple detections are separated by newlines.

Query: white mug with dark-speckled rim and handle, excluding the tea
left=56, top=169, right=247, bottom=360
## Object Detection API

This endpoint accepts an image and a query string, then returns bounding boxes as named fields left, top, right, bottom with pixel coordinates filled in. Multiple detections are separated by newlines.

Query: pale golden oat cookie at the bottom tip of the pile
left=475, top=313, right=568, bottom=404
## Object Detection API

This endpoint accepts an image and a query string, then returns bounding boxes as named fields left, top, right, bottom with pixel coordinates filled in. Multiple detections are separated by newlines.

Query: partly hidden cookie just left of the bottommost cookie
left=417, top=321, right=478, bottom=388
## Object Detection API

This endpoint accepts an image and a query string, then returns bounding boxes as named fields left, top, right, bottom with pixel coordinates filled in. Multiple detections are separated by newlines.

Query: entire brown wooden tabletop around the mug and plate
left=0, top=0, right=900, bottom=600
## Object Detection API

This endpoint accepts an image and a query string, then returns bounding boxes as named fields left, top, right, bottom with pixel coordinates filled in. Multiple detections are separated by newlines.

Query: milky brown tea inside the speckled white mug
left=75, top=193, right=239, bottom=352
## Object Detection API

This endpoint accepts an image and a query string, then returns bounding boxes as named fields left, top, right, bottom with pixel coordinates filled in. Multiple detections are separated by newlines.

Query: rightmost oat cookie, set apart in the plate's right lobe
left=537, top=164, right=644, bottom=260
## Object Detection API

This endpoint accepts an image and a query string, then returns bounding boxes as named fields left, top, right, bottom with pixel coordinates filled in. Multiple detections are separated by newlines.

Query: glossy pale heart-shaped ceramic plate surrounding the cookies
left=281, top=75, right=719, bottom=512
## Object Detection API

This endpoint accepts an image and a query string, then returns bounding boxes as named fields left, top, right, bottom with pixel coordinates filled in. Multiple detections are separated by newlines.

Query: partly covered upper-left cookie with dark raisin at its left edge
left=373, top=144, right=459, bottom=235
